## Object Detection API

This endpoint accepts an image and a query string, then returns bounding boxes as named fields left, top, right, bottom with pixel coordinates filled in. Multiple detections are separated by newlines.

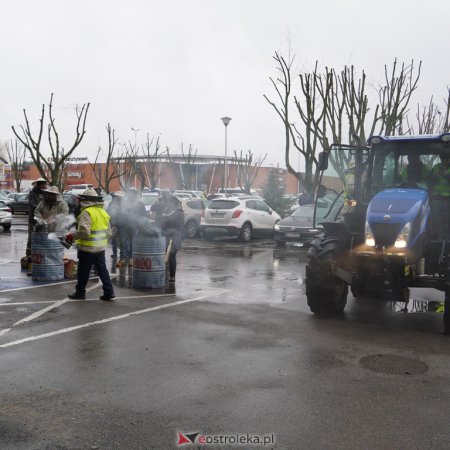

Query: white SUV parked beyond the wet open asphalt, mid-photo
left=200, top=196, right=281, bottom=242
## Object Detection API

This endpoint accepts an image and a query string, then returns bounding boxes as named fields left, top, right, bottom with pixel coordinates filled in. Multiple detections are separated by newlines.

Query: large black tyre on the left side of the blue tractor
left=305, top=237, right=348, bottom=316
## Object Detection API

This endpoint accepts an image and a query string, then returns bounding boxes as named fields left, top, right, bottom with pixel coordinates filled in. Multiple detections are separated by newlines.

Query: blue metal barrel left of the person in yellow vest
left=31, top=232, right=64, bottom=281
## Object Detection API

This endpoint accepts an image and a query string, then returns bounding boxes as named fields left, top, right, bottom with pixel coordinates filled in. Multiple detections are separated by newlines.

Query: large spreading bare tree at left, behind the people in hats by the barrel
left=11, top=94, right=90, bottom=189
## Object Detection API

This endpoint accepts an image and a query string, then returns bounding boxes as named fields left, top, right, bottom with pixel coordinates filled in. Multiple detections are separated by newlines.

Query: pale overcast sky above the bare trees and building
left=0, top=0, right=450, bottom=167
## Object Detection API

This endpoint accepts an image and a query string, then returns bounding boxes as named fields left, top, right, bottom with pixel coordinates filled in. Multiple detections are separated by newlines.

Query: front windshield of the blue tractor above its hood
left=364, top=140, right=450, bottom=199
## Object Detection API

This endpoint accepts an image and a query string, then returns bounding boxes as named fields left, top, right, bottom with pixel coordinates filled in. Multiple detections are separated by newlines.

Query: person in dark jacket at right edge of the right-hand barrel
left=161, top=196, right=184, bottom=283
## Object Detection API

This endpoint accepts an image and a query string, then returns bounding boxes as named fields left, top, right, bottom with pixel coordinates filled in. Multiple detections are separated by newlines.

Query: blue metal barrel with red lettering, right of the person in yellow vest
left=132, top=235, right=166, bottom=289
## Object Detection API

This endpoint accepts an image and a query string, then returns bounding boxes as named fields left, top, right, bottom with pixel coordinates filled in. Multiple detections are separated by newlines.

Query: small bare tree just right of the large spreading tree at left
left=89, top=123, right=121, bottom=194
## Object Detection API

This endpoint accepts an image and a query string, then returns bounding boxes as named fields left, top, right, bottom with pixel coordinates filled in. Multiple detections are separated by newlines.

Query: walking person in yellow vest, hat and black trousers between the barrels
left=66, top=189, right=115, bottom=300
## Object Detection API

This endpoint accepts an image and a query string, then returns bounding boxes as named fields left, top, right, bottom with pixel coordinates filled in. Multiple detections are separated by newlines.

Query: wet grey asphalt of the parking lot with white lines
left=0, top=216, right=450, bottom=449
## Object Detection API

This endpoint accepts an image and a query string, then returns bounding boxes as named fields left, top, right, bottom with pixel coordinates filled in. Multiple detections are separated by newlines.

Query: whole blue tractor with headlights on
left=305, top=133, right=450, bottom=333
